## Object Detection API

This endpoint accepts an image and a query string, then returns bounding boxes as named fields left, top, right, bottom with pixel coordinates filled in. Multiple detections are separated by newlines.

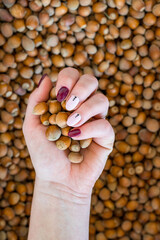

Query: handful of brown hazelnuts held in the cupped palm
left=33, top=87, right=92, bottom=163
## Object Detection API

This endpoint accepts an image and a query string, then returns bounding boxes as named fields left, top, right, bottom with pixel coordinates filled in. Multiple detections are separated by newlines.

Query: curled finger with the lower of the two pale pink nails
left=67, top=93, right=109, bottom=127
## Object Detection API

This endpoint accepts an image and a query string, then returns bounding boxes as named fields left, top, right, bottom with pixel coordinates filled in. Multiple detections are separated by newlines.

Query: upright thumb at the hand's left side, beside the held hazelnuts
left=24, top=74, right=52, bottom=129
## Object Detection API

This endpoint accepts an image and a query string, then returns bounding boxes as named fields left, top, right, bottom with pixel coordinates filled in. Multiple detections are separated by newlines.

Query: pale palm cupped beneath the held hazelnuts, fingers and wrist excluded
left=26, top=125, right=107, bottom=193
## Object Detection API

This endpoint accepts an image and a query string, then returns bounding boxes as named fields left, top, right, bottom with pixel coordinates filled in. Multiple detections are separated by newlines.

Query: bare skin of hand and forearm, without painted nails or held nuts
left=23, top=68, right=115, bottom=240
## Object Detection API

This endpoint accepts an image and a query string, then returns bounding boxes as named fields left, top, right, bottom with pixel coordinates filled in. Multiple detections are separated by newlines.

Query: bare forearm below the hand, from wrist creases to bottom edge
left=28, top=176, right=90, bottom=240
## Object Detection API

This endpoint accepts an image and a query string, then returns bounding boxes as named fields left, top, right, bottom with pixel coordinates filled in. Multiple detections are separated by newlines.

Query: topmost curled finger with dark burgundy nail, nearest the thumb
left=56, top=67, right=80, bottom=102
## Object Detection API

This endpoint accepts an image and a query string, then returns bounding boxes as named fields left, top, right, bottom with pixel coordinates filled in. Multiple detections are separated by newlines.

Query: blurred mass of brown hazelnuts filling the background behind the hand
left=0, top=0, right=160, bottom=240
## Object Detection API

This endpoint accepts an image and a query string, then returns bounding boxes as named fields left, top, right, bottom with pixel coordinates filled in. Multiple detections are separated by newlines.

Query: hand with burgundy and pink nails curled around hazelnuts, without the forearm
left=23, top=67, right=115, bottom=202
